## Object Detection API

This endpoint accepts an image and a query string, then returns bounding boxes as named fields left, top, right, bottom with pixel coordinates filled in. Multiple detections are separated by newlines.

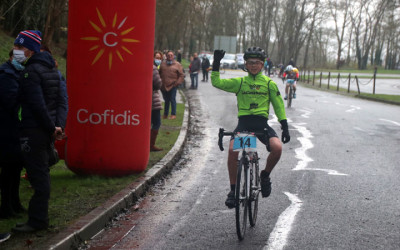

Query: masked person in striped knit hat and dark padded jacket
left=13, top=30, right=66, bottom=232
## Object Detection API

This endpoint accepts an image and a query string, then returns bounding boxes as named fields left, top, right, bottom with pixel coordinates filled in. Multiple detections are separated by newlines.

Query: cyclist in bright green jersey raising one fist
left=211, top=47, right=290, bottom=208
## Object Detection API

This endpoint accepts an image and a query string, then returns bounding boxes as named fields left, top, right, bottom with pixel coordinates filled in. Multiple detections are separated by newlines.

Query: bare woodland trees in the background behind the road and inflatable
left=0, top=0, right=400, bottom=70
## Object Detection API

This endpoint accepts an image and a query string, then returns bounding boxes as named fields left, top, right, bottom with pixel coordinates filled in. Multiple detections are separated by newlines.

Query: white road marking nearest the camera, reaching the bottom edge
left=263, top=192, right=302, bottom=250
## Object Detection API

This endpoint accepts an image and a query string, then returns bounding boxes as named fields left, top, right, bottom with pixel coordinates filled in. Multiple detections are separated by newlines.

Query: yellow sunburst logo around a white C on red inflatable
left=81, top=8, right=140, bottom=70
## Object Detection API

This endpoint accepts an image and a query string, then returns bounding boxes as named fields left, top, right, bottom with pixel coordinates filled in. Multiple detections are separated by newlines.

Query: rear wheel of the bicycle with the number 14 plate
left=249, top=153, right=260, bottom=227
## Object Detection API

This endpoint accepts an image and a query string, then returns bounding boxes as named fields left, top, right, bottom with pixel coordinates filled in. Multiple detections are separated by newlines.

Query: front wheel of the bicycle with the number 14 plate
left=235, top=157, right=248, bottom=240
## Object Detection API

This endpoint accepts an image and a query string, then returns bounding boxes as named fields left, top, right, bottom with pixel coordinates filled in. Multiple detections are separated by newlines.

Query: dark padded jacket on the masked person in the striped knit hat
left=19, top=52, right=68, bottom=135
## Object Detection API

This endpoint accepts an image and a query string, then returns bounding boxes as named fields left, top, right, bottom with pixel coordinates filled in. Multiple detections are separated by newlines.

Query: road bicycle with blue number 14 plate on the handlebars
left=218, top=128, right=265, bottom=240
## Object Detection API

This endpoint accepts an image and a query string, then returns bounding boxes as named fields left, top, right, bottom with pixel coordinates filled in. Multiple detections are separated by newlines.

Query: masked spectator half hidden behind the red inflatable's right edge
left=150, top=51, right=163, bottom=151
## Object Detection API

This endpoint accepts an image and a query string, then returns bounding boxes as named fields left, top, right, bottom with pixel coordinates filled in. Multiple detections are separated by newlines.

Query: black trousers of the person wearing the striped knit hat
left=20, top=128, right=52, bottom=228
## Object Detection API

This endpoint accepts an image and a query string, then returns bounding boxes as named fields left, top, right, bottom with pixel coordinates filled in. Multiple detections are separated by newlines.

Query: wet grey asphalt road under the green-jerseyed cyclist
left=88, top=71, right=400, bottom=249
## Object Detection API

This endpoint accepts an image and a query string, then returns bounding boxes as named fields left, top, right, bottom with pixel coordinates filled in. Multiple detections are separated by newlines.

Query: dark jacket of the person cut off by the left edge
left=0, top=61, right=20, bottom=159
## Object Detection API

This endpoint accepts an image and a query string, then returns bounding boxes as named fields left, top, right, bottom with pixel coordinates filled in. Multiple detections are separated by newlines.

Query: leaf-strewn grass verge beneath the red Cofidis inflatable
left=0, top=100, right=185, bottom=250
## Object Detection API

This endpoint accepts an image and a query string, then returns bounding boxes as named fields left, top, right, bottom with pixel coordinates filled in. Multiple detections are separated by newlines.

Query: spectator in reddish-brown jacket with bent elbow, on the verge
left=160, top=51, right=185, bottom=119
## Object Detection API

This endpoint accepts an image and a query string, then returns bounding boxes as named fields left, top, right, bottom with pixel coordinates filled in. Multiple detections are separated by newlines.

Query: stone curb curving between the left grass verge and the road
left=46, top=91, right=190, bottom=250
